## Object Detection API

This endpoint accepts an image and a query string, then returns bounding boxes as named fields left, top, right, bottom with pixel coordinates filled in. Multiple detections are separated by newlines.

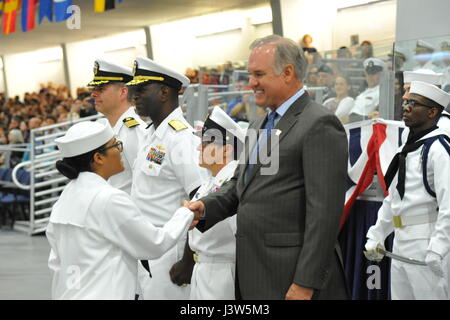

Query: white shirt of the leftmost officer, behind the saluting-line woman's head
left=108, top=107, right=147, bottom=194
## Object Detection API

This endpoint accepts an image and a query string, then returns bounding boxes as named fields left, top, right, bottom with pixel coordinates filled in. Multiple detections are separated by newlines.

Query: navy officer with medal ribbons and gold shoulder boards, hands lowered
left=128, top=57, right=208, bottom=300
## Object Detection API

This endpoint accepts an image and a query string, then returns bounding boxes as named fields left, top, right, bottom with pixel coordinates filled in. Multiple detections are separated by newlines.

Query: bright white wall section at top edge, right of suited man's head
left=281, top=0, right=396, bottom=51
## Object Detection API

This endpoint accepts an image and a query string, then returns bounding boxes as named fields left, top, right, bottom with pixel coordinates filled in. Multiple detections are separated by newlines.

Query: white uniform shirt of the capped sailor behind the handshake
left=189, top=161, right=238, bottom=260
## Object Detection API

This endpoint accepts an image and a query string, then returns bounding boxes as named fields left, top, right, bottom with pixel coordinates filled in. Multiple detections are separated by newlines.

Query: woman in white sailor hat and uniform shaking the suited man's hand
left=46, top=120, right=193, bottom=299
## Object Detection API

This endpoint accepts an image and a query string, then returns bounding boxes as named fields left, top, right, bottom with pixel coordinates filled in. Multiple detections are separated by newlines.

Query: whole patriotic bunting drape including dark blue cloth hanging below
left=339, top=119, right=405, bottom=300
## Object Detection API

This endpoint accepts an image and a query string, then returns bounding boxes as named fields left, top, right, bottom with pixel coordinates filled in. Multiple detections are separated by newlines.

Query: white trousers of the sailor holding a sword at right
left=391, top=238, right=449, bottom=300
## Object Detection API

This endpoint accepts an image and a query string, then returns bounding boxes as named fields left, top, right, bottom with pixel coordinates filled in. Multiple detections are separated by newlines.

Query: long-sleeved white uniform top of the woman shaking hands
left=46, top=172, right=193, bottom=299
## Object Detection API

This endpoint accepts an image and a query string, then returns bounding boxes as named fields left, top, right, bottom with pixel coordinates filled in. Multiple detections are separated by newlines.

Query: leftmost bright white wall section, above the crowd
left=4, top=47, right=65, bottom=97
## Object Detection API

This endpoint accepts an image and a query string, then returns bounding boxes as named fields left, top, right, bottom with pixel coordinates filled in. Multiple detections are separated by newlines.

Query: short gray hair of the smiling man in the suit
left=250, top=34, right=308, bottom=81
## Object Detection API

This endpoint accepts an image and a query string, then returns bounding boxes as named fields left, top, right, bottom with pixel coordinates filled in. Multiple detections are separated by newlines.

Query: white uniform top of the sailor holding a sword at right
left=367, top=129, right=450, bottom=258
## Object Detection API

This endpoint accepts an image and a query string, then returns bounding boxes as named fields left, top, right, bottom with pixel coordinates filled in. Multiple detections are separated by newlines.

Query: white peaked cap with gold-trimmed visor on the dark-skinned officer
left=127, top=57, right=190, bottom=90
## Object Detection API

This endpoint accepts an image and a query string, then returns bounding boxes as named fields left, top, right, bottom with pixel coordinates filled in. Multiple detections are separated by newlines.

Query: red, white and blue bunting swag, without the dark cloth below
left=341, top=119, right=405, bottom=228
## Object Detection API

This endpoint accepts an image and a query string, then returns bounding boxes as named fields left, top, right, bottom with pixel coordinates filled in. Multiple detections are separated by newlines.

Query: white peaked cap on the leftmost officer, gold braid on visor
left=88, top=59, right=133, bottom=87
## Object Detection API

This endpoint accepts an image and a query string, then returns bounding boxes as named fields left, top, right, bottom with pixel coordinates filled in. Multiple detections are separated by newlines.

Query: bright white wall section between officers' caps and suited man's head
left=150, top=6, right=272, bottom=72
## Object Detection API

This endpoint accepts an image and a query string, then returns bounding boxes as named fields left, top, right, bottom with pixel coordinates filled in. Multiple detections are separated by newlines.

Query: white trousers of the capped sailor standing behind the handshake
left=190, top=254, right=236, bottom=300
